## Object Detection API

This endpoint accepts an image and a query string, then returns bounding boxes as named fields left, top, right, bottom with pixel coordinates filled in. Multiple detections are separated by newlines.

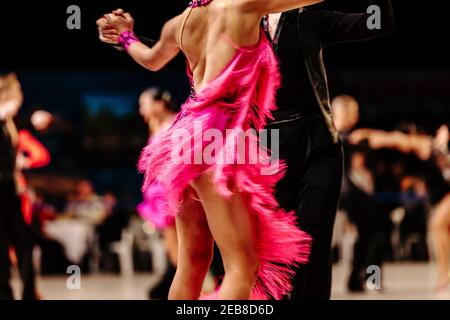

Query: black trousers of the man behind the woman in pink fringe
left=268, top=113, right=342, bottom=300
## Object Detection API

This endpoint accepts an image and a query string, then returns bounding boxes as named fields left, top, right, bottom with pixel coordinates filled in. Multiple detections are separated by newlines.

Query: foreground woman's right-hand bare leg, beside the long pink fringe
left=193, top=173, right=259, bottom=300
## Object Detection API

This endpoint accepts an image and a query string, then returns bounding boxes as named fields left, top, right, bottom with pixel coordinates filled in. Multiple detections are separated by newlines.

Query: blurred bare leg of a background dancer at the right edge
left=431, top=195, right=450, bottom=288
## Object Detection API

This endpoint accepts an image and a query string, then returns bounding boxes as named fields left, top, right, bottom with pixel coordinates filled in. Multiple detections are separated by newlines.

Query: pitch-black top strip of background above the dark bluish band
left=0, top=0, right=450, bottom=70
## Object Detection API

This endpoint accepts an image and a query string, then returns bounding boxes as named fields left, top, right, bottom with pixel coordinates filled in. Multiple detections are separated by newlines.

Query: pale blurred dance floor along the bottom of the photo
left=13, top=263, right=450, bottom=300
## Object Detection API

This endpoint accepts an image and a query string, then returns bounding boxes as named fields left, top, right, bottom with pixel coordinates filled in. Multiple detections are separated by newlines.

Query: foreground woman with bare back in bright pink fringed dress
left=98, top=0, right=320, bottom=299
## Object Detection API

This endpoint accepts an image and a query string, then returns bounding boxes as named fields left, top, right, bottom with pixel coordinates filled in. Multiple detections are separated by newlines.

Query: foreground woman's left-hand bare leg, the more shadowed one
left=169, top=191, right=213, bottom=300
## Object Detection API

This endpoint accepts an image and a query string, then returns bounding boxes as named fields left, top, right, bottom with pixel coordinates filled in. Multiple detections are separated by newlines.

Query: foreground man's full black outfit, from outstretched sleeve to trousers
left=268, top=0, right=394, bottom=300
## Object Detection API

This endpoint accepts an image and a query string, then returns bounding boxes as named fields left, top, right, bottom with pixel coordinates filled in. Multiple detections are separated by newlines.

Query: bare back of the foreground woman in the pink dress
left=177, top=0, right=261, bottom=91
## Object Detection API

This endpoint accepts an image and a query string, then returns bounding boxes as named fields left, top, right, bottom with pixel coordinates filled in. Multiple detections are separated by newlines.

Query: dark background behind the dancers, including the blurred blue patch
left=0, top=0, right=450, bottom=203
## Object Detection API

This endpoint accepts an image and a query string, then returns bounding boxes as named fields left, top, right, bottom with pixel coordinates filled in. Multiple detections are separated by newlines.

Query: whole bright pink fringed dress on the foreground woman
left=139, top=24, right=311, bottom=299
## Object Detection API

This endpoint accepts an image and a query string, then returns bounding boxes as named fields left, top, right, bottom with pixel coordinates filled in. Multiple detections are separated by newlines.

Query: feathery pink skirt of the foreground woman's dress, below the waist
left=139, top=102, right=311, bottom=299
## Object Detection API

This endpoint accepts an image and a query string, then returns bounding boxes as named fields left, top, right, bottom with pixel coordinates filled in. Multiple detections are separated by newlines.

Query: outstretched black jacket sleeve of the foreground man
left=316, top=0, right=395, bottom=46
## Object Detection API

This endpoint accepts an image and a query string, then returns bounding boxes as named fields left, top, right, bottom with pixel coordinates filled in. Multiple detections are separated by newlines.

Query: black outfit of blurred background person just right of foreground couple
left=341, top=144, right=402, bottom=291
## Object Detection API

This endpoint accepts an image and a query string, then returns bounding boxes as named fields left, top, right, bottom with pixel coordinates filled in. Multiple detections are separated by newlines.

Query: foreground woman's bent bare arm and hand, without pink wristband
left=97, top=13, right=180, bottom=71
